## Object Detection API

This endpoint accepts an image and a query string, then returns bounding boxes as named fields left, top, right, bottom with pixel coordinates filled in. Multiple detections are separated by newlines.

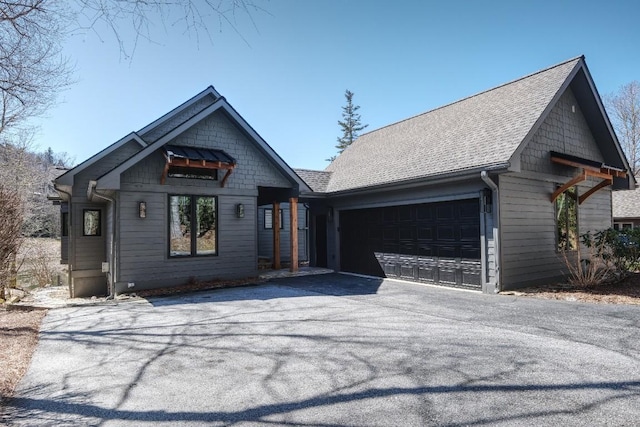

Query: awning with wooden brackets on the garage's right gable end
left=551, top=151, right=627, bottom=204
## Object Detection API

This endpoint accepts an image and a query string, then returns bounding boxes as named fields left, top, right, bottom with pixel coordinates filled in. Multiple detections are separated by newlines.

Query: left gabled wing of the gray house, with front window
left=54, top=87, right=310, bottom=297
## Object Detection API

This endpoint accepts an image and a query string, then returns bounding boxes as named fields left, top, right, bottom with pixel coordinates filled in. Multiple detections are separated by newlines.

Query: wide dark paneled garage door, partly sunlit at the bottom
left=340, top=199, right=481, bottom=288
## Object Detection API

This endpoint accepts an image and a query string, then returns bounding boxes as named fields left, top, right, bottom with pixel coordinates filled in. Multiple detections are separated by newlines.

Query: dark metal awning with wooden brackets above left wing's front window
left=160, top=145, right=236, bottom=187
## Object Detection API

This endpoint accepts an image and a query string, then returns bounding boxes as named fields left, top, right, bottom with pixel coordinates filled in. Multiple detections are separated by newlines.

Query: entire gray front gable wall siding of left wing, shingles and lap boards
left=111, top=109, right=291, bottom=292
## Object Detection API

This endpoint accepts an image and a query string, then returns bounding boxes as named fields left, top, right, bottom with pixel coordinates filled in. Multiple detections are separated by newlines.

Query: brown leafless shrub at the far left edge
left=0, top=184, right=22, bottom=299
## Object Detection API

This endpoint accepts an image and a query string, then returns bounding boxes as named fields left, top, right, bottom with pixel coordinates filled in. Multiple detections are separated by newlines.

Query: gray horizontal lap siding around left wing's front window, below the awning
left=119, top=192, right=257, bottom=288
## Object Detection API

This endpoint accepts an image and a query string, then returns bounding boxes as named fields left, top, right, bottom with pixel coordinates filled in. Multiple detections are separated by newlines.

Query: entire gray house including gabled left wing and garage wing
left=55, top=57, right=636, bottom=296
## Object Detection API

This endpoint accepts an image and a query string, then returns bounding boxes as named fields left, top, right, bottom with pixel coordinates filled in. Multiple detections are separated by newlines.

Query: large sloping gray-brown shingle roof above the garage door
left=326, top=57, right=582, bottom=192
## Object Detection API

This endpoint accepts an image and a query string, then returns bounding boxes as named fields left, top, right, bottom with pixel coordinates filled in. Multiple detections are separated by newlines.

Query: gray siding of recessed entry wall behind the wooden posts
left=258, top=203, right=309, bottom=262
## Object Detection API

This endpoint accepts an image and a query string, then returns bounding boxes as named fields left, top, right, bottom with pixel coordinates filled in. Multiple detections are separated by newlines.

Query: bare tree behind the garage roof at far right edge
left=606, top=81, right=640, bottom=176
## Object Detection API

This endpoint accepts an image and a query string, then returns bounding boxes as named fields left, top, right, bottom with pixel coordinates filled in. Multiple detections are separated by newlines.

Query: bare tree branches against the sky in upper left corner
left=0, top=0, right=262, bottom=136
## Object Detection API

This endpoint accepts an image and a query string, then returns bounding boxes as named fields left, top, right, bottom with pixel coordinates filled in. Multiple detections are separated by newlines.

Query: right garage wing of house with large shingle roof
left=301, top=57, right=635, bottom=293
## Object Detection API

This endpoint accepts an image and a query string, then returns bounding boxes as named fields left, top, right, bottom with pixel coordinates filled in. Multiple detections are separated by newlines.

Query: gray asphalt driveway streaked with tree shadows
left=2, top=274, right=640, bottom=426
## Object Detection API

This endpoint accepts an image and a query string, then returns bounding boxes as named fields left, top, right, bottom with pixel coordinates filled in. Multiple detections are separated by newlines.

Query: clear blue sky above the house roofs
left=35, top=0, right=640, bottom=169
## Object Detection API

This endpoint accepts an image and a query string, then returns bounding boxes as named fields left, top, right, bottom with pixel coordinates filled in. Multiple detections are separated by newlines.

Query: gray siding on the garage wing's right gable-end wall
left=500, top=89, right=611, bottom=289
